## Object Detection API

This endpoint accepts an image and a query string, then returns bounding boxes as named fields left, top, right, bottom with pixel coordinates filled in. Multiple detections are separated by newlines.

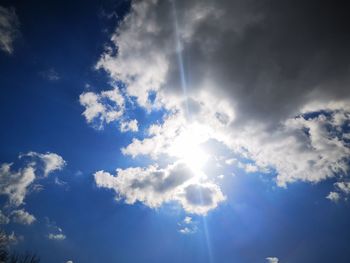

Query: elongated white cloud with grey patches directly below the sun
left=94, top=162, right=225, bottom=214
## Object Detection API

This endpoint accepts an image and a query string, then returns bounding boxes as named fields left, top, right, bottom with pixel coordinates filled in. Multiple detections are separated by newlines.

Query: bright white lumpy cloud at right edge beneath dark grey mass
left=235, top=112, right=350, bottom=187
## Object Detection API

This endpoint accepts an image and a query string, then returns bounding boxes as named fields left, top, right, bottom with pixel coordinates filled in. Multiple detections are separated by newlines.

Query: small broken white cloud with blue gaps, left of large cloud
left=79, top=88, right=125, bottom=129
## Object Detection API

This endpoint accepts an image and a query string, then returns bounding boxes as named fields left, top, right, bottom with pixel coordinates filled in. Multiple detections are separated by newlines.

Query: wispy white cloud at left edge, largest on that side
left=0, top=152, right=65, bottom=206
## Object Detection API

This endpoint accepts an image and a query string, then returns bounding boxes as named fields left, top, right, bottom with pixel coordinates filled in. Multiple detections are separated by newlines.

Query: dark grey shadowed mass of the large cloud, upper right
left=172, top=1, right=350, bottom=125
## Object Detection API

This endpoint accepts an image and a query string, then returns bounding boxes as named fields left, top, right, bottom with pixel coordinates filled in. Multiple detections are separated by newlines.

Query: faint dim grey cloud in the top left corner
left=0, top=6, right=19, bottom=54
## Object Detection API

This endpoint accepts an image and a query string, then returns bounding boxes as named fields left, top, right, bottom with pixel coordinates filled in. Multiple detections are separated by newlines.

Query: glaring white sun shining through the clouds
left=169, top=124, right=209, bottom=175
